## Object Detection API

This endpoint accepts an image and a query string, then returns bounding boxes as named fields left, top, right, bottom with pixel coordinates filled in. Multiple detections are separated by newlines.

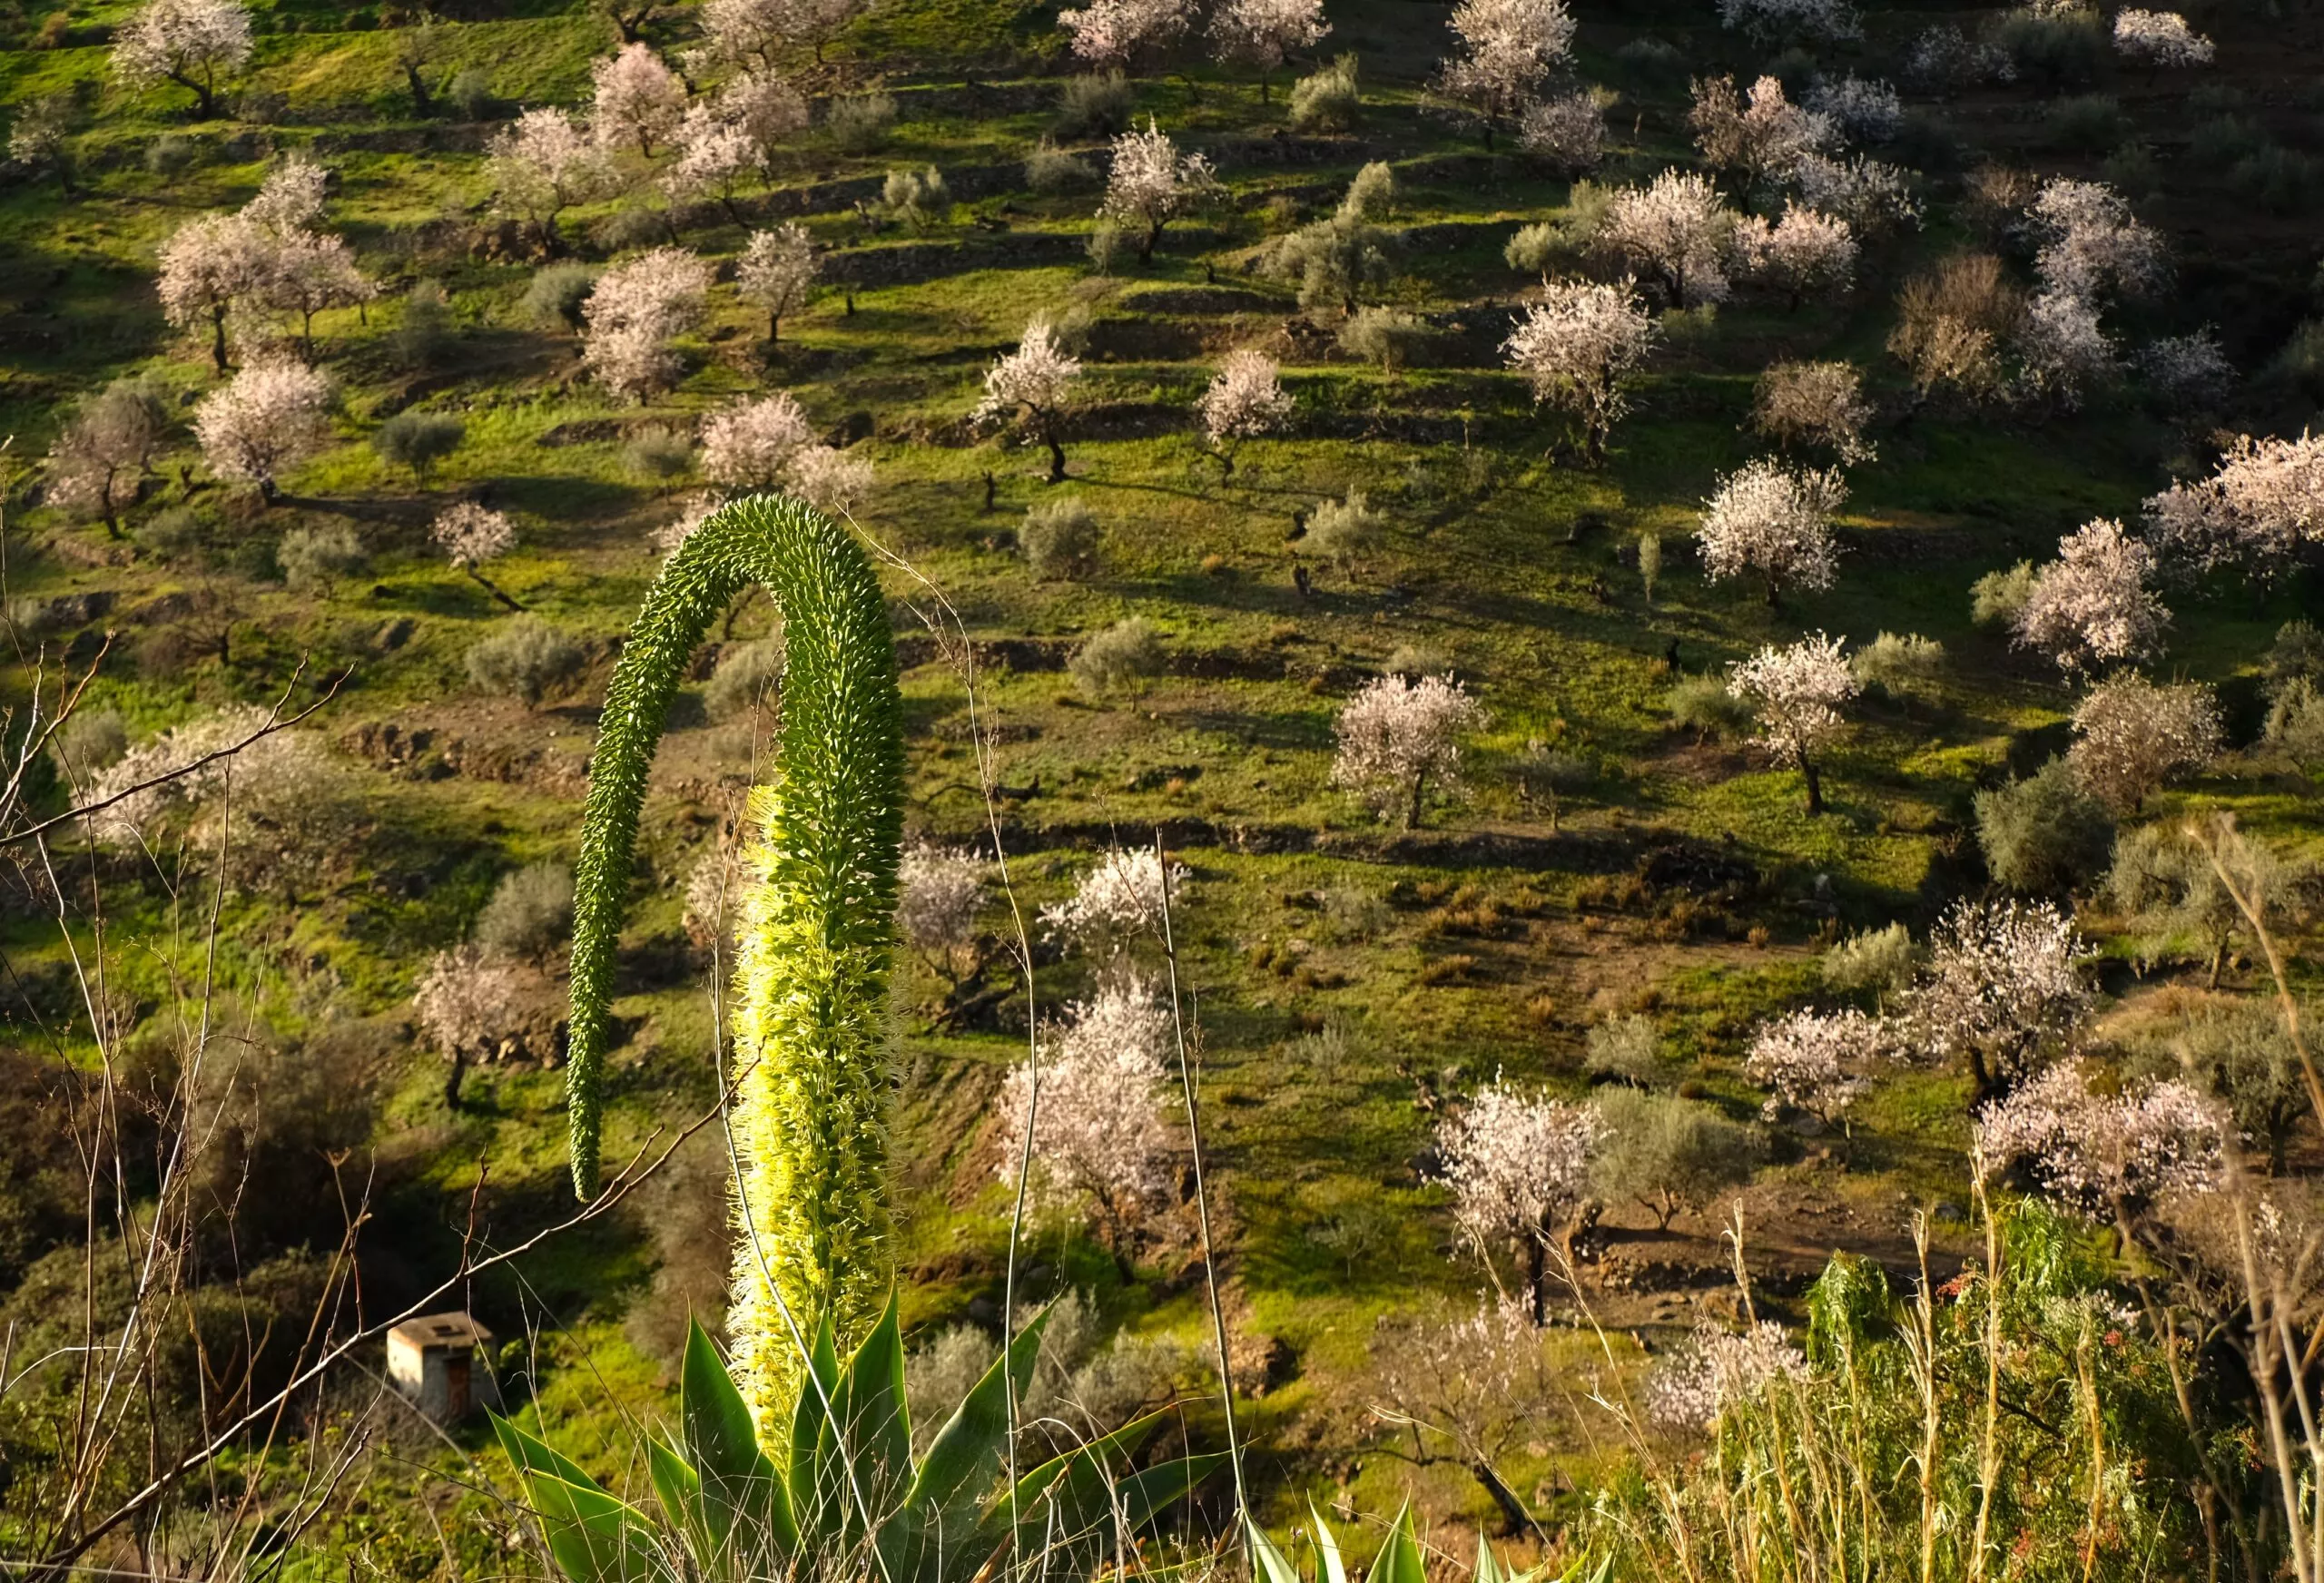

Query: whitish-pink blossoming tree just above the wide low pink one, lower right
left=1904, top=902, right=2089, bottom=1095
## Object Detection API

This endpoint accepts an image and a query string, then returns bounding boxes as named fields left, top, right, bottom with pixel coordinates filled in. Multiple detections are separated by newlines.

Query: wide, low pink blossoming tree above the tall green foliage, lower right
left=1975, top=1062, right=2229, bottom=1218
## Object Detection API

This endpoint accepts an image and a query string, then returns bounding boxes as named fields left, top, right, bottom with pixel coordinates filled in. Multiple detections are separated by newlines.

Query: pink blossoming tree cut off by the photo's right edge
left=2145, top=430, right=2324, bottom=581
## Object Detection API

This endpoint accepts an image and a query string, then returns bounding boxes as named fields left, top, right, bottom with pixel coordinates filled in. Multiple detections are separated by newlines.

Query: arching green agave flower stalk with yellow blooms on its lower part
left=567, top=495, right=904, bottom=1425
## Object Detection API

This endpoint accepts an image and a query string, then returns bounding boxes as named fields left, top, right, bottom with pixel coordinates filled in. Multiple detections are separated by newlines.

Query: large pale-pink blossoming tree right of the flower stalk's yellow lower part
left=997, top=977, right=1176, bottom=1257
